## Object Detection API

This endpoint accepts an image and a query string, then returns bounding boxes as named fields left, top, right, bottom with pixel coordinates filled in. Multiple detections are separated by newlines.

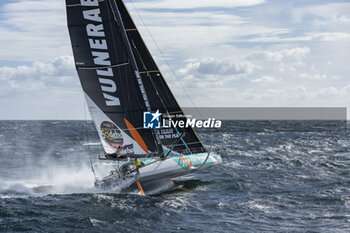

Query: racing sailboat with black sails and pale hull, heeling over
left=66, top=0, right=221, bottom=194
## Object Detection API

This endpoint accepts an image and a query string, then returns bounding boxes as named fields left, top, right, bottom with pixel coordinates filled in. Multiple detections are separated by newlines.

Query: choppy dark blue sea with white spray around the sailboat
left=0, top=121, right=350, bottom=232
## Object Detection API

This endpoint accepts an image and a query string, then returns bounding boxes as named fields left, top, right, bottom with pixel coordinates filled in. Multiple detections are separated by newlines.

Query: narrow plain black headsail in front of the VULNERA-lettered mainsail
left=115, top=0, right=205, bottom=154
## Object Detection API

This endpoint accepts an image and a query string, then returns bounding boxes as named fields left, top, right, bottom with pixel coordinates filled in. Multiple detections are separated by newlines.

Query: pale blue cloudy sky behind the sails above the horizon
left=0, top=0, right=350, bottom=120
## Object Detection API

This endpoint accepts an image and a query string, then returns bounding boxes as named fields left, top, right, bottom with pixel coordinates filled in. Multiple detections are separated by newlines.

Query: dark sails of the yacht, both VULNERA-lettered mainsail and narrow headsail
left=66, top=0, right=203, bottom=157
